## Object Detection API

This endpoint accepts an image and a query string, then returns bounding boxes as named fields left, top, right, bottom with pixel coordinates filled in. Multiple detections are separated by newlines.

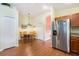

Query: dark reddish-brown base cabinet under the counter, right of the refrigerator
left=71, top=36, right=79, bottom=54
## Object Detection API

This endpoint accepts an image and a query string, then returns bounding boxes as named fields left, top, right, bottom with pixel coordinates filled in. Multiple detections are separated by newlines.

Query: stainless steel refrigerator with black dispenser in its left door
left=52, top=19, right=70, bottom=53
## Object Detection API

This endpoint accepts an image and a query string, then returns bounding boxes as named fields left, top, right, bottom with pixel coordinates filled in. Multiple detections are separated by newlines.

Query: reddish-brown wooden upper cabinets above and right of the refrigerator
left=55, top=13, right=79, bottom=26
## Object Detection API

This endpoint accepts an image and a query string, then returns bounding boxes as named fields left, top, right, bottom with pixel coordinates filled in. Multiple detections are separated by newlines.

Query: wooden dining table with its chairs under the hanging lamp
left=20, top=31, right=37, bottom=42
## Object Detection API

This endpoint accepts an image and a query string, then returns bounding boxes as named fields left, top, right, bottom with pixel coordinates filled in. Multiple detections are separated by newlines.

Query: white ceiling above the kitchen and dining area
left=12, top=3, right=79, bottom=16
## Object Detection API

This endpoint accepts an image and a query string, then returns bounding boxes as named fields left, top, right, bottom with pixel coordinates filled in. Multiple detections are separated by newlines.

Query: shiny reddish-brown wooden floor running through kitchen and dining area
left=0, top=40, right=78, bottom=56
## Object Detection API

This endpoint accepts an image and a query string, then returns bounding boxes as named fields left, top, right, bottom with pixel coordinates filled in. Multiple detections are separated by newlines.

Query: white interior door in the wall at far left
left=2, top=16, right=17, bottom=49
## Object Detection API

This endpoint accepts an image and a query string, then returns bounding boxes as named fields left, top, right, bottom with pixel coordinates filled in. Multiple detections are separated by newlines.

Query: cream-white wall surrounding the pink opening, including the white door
left=34, top=8, right=55, bottom=41
